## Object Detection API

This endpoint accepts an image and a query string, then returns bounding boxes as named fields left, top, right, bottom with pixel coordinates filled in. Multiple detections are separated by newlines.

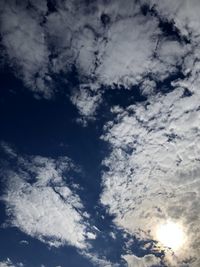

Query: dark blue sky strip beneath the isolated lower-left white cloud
left=0, top=228, right=93, bottom=267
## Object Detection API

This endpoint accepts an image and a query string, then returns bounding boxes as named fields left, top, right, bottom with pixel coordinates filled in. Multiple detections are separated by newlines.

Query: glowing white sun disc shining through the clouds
left=156, top=221, right=185, bottom=251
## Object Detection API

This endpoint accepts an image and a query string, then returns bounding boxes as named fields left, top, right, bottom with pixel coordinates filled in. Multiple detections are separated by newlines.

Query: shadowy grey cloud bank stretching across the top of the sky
left=0, top=0, right=195, bottom=118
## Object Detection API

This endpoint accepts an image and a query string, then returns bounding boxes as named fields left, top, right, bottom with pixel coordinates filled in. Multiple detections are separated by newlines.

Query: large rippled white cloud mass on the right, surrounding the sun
left=101, top=78, right=200, bottom=266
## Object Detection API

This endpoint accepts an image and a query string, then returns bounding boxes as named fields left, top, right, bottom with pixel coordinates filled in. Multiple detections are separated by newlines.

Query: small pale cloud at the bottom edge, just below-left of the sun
left=123, top=254, right=161, bottom=267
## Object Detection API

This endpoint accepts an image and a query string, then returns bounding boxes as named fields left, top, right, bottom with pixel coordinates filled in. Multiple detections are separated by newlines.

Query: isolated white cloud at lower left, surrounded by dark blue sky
left=2, top=148, right=95, bottom=249
